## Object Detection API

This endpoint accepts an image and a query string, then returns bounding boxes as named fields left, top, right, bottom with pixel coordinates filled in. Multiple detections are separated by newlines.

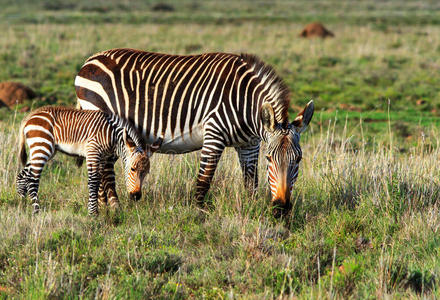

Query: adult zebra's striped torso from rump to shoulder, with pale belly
left=75, top=49, right=258, bottom=153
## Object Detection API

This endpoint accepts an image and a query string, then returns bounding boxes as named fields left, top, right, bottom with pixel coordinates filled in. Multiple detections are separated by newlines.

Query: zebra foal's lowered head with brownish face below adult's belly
left=122, top=129, right=162, bottom=201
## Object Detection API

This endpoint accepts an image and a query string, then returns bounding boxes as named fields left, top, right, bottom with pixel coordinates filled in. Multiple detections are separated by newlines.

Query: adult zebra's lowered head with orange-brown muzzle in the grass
left=261, top=101, right=314, bottom=216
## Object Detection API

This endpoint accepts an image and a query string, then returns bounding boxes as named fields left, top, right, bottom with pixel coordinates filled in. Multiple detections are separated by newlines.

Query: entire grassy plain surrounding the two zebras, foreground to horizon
left=0, top=0, right=440, bottom=299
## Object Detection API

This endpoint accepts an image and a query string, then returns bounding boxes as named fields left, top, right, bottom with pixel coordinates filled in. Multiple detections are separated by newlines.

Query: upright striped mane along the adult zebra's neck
left=240, top=53, right=290, bottom=125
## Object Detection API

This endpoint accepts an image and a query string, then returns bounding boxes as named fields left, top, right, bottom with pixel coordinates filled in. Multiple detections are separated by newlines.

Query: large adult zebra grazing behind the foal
left=75, top=49, right=314, bottom=212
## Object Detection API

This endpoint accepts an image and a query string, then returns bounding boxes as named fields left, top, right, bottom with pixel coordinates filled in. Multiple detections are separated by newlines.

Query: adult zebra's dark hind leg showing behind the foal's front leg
left=98, top=157, right=119, bottom=209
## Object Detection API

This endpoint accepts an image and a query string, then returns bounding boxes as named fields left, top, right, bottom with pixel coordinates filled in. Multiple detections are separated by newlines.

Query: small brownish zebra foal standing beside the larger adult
left=17, top=106, right=161, bottom=215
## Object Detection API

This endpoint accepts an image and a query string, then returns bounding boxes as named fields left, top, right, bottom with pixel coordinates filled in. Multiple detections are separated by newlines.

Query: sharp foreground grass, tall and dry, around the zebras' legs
left=0, top=112, right=440, bottom=299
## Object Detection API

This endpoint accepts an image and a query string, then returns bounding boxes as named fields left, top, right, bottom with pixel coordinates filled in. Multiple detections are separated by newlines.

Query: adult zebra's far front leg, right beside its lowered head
left=235, top=143, right=260, bottom=196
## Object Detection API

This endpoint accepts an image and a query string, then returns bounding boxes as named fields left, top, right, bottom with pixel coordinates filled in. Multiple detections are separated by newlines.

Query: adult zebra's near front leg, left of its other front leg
left=195, top=137, right=225, bottom=205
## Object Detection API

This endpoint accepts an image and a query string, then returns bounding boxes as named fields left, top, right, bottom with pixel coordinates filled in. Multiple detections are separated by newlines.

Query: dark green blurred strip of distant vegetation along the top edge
left=1, top=0, right=440, bottom=27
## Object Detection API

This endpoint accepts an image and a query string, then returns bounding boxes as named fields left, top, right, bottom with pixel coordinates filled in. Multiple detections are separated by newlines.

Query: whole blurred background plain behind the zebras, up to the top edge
left=0, top=0, right=440, bottom=144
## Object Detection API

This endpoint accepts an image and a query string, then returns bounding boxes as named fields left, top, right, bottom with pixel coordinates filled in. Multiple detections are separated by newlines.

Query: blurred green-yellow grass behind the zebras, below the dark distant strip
left=0, top=11, right=440, bottom=135
